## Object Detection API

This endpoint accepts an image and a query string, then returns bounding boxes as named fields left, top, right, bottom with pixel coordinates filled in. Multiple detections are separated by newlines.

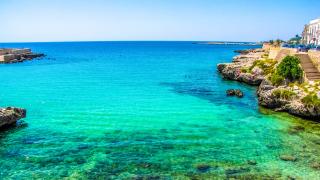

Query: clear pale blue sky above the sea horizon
left=0, top=0, right=320, bottom=42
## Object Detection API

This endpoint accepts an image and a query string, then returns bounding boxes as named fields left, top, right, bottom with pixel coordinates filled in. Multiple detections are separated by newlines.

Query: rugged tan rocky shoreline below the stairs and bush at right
left=217, top=51, right=320, bottom=121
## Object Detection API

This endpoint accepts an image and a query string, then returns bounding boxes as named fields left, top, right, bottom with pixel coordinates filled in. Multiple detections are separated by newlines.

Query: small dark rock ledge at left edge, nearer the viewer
left=0, top=107, right=26, bottom=129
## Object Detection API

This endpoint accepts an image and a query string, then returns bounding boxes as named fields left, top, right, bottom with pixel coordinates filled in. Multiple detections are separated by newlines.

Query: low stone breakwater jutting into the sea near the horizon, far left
left=0, top=48, right=45, bottom=64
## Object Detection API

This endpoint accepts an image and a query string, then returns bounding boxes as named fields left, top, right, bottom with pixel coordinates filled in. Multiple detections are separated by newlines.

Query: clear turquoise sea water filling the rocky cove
left=0, top=42, right=320, bottom=179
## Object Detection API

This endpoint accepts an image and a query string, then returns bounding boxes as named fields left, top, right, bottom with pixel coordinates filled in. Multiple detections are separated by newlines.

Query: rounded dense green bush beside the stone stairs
left=277, top=56, right=303, bottom=82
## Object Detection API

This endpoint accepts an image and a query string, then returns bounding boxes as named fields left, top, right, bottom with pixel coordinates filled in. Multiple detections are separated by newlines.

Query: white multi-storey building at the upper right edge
left=302, top=18, right=320, bottom=45
